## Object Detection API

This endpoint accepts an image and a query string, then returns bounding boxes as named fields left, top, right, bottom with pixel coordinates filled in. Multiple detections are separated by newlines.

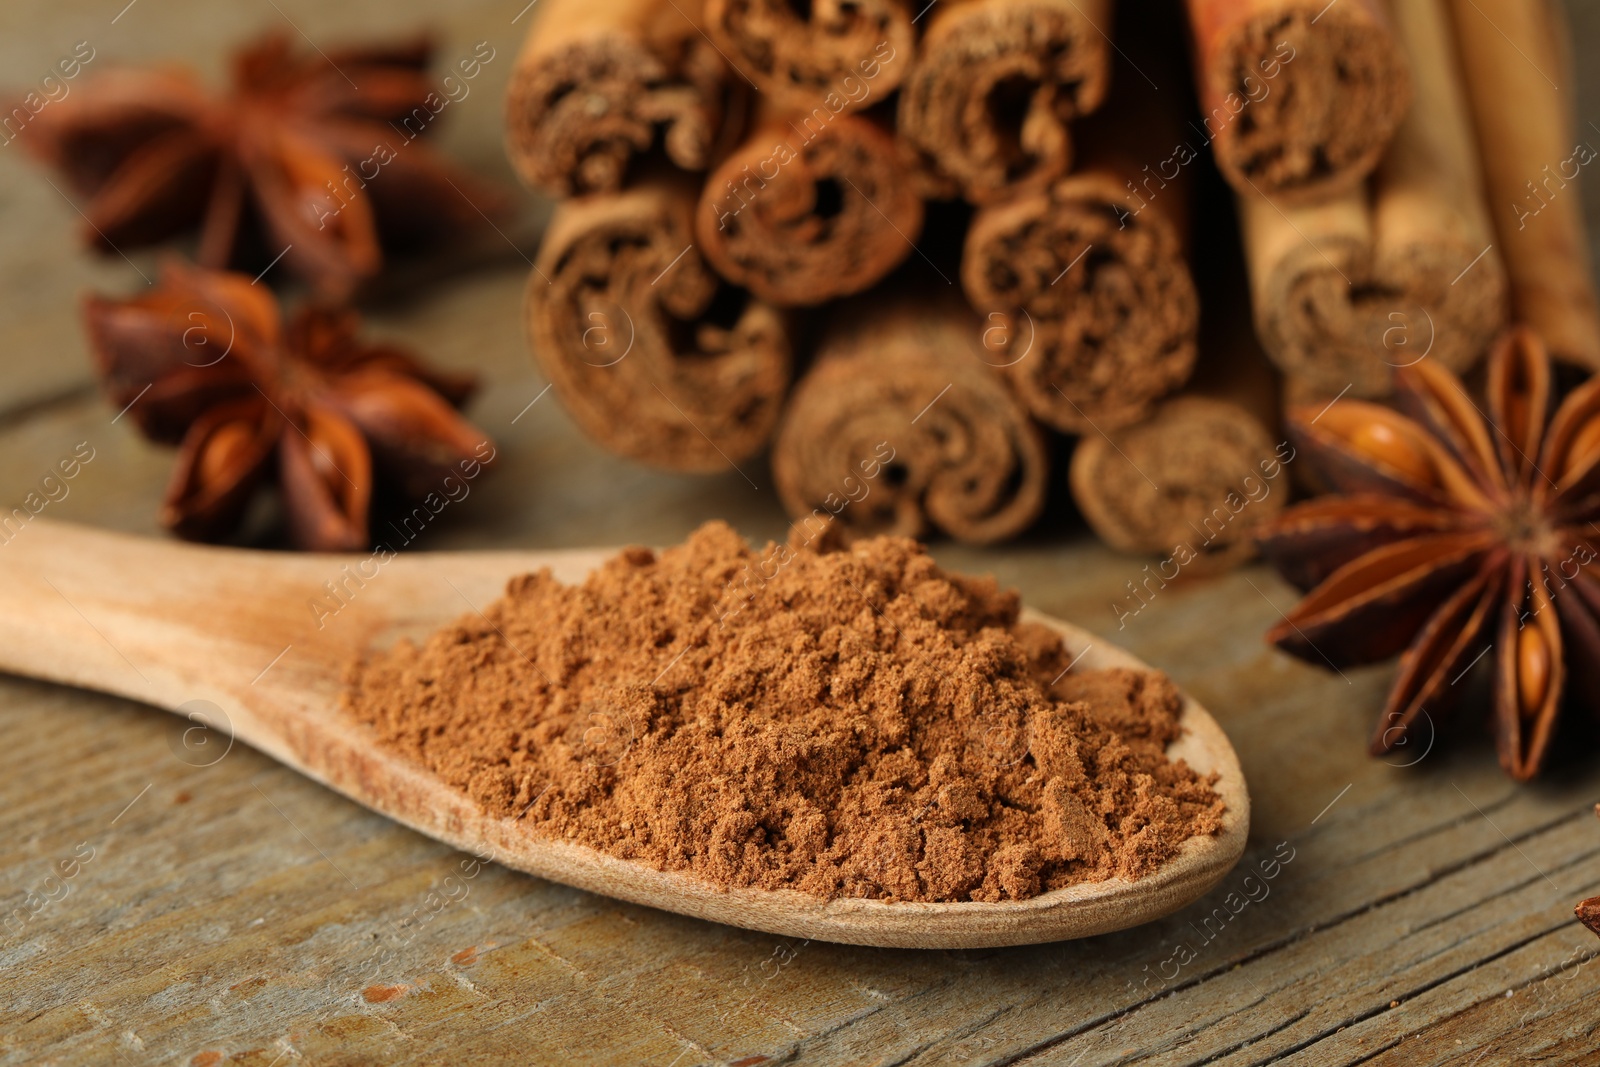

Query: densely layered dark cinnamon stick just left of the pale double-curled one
left=962, top=26, right=1200, bottom=434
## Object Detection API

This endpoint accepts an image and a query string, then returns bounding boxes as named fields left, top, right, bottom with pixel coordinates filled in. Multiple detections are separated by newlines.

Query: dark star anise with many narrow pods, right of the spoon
left=1262, top=330, right=1600, bottom=781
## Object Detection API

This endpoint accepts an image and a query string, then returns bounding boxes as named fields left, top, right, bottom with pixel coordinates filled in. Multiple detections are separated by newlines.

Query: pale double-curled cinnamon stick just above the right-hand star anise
left=1238, top=0, right=1506, bottom=397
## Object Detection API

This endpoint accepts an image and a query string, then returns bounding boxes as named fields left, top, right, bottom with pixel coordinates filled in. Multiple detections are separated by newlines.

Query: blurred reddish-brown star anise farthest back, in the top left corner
left=24, top=35, right=504, bottom=299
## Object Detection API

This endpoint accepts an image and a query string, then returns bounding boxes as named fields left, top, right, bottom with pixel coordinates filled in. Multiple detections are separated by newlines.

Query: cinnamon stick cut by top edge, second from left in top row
left=706, top=0, right=915, bottom=112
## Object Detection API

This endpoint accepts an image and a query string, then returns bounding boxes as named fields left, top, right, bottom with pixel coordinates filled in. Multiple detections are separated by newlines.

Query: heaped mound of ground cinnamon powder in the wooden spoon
left=346, top=523, right=1222, bottom=901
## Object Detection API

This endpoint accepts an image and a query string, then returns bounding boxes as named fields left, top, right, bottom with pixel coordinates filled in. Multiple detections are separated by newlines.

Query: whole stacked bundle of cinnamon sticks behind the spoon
left=507, top=0, right=1600, bottom=565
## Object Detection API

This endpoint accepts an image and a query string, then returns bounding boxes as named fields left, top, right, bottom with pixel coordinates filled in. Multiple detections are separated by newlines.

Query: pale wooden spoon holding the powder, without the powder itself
left=0, top=520, right=1250, bottom=949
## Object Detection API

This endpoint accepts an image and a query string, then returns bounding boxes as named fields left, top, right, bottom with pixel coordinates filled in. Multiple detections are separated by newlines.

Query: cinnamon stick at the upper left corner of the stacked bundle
left=506, top=0, right=726, bottom=197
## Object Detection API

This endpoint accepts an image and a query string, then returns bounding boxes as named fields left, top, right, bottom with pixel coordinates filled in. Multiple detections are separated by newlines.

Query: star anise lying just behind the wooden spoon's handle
left=85, top=262, right=494, bottom=552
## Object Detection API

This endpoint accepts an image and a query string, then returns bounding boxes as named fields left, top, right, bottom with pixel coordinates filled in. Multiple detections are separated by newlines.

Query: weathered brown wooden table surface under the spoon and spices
left=0, top=0, right=1600, bottom=1067
